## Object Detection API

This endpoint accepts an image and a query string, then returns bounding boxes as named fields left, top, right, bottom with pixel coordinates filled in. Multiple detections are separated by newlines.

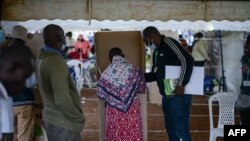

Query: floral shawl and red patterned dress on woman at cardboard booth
left=97, top=56, right=146, bottom=141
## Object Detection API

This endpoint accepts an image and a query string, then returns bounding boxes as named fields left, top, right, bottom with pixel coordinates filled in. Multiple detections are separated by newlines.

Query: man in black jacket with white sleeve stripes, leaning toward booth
left=143, top=26, right=194, bottom=141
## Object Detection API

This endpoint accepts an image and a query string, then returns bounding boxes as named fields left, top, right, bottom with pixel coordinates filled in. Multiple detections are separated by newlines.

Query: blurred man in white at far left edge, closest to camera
left=0, top=44, right=35, bottom=141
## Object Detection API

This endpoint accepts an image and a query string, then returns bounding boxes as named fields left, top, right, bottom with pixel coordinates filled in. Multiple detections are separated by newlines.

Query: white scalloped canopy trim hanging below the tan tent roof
left=2, top=19, right=250, bottom=33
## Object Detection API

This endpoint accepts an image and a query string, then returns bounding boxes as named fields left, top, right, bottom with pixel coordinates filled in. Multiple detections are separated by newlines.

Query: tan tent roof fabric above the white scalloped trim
left=1, top=0, right=250, bottom=21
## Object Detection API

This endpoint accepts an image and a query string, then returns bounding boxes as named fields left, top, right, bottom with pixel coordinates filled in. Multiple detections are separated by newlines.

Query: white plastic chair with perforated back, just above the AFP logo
left=208, top=92, right=237, bottom=141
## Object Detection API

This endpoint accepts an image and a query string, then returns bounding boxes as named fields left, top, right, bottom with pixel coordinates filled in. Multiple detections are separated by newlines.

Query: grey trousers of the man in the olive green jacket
left=43, top=122, right=82, bottom=141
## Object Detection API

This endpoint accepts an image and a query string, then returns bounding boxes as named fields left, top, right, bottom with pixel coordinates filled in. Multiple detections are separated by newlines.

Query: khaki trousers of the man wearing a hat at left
left=13, top=105, right=35, bottom=141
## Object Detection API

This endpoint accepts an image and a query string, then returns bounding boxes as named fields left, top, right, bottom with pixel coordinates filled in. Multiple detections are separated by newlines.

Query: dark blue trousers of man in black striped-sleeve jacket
left=162, top=94, right=192, bottom=141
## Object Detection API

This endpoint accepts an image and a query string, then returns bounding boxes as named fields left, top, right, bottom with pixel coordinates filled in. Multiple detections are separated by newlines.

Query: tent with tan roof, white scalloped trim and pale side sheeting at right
left=0, top=0, right=250, bottom=140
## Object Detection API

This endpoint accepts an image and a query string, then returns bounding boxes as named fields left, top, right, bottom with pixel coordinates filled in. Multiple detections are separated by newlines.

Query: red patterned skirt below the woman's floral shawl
left=105, top=97, right=143, bottom=141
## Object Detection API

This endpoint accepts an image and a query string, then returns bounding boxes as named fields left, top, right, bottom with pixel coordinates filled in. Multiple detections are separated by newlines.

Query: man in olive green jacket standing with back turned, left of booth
left=36, top=24, right=85, bottom=141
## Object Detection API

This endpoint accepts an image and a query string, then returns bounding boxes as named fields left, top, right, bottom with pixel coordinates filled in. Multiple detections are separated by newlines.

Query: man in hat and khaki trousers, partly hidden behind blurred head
left=3, top=25, right=36, bottom=141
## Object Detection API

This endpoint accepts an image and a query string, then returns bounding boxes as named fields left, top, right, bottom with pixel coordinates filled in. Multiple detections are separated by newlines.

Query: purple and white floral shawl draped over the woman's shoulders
left=97, top=56, right=145, bottom=112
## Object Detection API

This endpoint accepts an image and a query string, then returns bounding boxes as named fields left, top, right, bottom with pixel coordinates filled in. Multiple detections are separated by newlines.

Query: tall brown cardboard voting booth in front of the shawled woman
left=95, top=31, right=147, bottom=141
